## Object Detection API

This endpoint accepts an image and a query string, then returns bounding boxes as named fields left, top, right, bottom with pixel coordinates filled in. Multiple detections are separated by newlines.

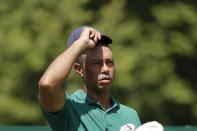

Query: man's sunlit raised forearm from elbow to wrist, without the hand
left=39, top=41, right=83, bottom=87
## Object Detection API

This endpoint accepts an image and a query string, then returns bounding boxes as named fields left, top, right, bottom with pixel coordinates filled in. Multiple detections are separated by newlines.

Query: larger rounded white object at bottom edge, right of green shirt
left=135, top=121, right=164, bottom=131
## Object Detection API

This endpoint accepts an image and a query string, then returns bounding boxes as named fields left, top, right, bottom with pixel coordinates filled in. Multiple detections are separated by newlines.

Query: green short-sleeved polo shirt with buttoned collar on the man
left=41, top=89, right=141, bottom=131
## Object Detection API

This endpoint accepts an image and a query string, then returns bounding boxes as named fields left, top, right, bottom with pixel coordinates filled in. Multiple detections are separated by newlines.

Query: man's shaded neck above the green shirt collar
left=83, top=86, right=111, bottom=110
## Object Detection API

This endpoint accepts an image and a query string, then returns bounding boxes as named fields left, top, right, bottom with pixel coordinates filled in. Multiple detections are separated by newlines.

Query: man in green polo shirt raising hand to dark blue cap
left=39, top=26, right=141, bottom=131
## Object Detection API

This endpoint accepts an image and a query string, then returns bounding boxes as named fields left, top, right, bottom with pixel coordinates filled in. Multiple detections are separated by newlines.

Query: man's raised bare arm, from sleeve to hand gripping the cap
left=39, top=28, right=101, bottom=112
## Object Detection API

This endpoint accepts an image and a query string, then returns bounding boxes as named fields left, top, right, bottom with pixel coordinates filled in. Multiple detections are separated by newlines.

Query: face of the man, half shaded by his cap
left=83, top=44, right=115, bottom=90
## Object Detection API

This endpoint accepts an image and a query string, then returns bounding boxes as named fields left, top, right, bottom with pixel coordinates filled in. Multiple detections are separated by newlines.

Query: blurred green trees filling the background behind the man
left=0, top=0, right=197, bottom=125
